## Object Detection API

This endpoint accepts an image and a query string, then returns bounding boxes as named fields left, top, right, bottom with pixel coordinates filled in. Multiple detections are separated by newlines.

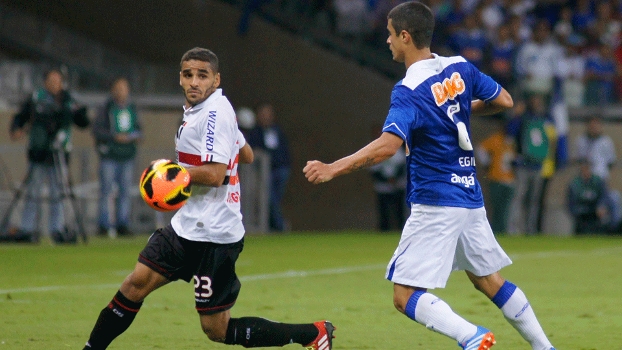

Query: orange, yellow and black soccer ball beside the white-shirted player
left=140, top=159, right=191, bottom=211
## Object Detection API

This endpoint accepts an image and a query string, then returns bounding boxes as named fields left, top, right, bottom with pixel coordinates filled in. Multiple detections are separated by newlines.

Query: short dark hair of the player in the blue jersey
left=387, top=1, right=434, bottom=49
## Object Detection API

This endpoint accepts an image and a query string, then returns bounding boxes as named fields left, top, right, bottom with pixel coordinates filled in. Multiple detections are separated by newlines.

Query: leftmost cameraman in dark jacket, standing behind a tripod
left=10, top=69, right=89, bottom=243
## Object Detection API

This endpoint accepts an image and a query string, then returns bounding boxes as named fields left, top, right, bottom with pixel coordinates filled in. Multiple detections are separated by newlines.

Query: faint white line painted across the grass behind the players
left=0, top=246, right=622, bottom=294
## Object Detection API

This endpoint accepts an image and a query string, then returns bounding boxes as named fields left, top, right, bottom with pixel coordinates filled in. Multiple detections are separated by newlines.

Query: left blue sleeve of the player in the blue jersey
left=382, top=85, right=417, bottom=144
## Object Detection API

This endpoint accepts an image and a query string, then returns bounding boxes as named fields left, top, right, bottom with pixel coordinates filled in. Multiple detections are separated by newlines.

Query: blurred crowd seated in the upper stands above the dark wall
left=233, top=0, right=622, bottom=106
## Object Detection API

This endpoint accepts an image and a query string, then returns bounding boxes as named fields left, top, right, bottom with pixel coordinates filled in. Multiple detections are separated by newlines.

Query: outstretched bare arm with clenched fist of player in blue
left=302, top=132, right=404, bottom=185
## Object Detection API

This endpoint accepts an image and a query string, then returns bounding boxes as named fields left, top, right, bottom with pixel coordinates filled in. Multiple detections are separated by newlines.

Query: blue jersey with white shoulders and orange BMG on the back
left=383, top=55, right=501, bottom=208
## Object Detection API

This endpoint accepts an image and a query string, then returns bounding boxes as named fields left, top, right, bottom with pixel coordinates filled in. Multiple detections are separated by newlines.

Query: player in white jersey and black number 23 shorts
left=84, top=48, right=334, bottom=350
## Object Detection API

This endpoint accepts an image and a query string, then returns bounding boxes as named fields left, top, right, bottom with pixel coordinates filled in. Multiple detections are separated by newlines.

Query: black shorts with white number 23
left=138, top=225, right=244, bottom=315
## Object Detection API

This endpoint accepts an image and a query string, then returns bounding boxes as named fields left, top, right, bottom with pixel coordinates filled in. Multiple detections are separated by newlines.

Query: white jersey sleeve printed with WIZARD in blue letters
left=201, top=104, right=238, bottom=164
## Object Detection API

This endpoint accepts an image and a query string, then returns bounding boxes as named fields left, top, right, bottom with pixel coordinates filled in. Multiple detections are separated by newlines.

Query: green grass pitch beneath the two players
left=0, top=232, right=622, bottom=350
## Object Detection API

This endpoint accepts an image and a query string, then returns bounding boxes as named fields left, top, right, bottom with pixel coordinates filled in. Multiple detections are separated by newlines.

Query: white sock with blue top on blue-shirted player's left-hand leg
left=406, top=291, right=477, bottom=343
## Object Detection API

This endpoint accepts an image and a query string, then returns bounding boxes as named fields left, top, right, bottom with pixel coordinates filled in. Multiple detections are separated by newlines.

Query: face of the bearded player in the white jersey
left=179, top=60, right=220, bottom=107
